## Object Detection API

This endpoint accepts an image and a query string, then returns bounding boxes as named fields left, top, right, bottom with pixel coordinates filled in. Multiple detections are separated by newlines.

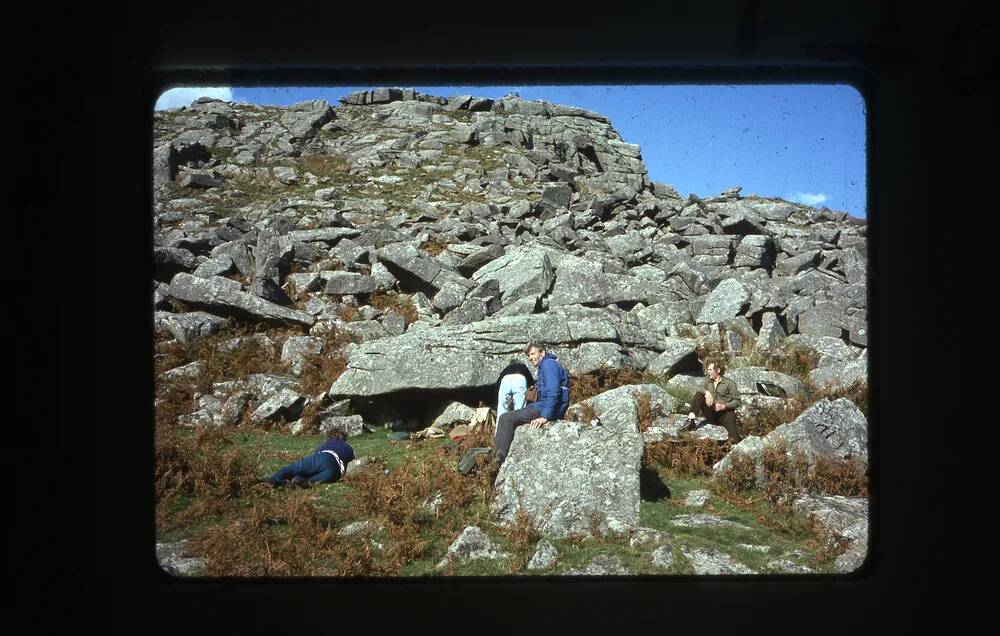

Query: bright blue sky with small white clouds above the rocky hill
left=156, top=84, right=866, bottom=217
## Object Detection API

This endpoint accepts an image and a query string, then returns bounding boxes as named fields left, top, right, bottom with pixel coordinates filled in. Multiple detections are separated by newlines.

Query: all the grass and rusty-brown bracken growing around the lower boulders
left=155, top=322, right=867, bottom=577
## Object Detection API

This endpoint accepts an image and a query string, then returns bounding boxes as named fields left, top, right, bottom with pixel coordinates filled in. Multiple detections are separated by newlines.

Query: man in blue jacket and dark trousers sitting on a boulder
left=494, top=342, right=570, bottom=465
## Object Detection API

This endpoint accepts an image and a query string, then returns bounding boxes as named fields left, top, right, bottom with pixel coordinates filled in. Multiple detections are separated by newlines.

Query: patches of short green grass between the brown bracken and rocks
left=158, top=430, right=829, bottom=576
